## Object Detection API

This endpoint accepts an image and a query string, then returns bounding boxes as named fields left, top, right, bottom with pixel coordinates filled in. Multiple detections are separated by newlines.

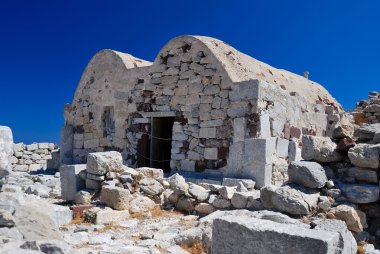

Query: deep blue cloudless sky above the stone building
left=0, top=0, right=380, bottom=143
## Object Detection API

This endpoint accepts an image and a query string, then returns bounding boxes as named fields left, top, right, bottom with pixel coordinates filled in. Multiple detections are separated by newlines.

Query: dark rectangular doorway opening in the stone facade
left=150, top=117, right=174, bottom=172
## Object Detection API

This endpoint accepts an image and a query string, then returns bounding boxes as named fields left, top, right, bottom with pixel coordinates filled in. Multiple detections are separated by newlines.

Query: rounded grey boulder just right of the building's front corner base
left=288, top=161, right=327, bottom=188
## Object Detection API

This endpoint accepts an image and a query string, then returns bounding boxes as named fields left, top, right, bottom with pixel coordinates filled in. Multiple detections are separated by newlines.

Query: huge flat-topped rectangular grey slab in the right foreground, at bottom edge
left=211, top=215, right=339, bottom=254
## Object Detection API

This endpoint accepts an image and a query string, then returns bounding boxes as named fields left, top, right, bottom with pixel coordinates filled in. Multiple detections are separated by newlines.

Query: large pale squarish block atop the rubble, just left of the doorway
left=86, top=151, right=123, bottom=175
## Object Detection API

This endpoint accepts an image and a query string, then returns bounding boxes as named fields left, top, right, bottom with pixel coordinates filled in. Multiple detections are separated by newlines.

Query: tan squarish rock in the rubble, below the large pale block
left=100, top=186, right=132, bottom=210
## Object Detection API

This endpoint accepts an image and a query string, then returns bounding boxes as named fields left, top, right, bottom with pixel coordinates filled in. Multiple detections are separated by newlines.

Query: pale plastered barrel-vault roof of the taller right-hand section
left=155, top=35, right=341, bottom=109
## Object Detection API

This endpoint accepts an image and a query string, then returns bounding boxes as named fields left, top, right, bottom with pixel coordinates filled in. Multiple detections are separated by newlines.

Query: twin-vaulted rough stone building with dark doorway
left=61, top=36, right=343, bottom=187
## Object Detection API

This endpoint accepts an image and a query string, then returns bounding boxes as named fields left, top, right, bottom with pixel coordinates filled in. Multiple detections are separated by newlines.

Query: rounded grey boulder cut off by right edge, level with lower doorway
left=348, top=144, right=380, bottom=169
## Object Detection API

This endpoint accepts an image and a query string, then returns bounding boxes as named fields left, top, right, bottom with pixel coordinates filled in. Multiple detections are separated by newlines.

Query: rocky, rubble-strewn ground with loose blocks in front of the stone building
left=0, top=106, right=380, bottom=254
